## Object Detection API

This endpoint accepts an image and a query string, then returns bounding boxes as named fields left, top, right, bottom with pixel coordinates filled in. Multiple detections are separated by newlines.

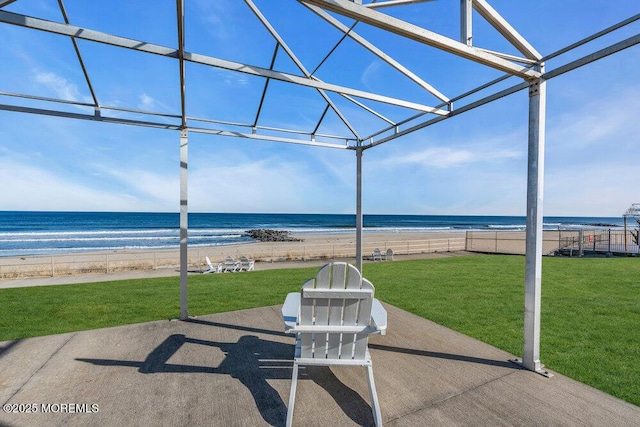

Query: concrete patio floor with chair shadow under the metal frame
left=0, top=305, right=640, bottom=426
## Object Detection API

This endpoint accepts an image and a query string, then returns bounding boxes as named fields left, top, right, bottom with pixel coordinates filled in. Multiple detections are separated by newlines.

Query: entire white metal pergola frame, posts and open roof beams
left=0, top=0, right=640, bottom=374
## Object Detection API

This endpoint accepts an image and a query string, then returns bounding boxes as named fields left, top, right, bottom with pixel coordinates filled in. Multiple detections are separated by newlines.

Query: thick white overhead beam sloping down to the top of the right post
left=298, top=0, right=540, bottom=80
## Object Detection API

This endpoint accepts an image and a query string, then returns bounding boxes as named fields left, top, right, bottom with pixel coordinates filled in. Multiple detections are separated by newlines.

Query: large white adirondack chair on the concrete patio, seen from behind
left=282, top=262, right=387, bottom=426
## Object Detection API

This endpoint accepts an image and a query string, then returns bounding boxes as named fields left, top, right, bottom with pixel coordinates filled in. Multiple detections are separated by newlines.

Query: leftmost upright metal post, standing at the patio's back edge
left=180, top=129, right=189, bottom=320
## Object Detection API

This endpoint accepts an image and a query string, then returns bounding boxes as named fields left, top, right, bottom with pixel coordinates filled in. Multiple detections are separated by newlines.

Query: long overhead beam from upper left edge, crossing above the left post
left=0, top=10, right=449, bottom=115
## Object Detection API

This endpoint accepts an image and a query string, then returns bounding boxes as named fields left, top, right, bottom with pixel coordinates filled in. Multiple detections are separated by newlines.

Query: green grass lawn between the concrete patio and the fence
left=0, top=255, right=640, bottom=406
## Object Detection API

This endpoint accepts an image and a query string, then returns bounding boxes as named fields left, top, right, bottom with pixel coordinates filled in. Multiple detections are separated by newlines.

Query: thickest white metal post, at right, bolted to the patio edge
left=522, top=65, right=547, bottom=374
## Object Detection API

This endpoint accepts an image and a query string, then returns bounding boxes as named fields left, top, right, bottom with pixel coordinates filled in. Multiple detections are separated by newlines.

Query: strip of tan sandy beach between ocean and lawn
left=0, top=231, right=600, bottom=287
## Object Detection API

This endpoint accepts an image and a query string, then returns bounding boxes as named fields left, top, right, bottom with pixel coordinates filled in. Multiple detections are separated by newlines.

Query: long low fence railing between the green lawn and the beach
left=0, top=230, right=640, bottom=279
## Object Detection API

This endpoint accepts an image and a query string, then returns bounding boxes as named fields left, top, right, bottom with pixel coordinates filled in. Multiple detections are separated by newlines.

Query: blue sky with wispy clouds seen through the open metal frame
left=0, top=0, right=640, bottom=216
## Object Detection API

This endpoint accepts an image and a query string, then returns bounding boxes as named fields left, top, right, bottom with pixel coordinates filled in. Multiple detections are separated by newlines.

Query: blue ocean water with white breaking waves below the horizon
left=0, top=211, right=623, bottom=256
